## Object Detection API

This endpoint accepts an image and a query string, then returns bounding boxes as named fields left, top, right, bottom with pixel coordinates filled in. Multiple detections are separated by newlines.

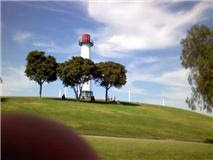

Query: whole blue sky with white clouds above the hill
left=1, top=0, right=213, bottom=108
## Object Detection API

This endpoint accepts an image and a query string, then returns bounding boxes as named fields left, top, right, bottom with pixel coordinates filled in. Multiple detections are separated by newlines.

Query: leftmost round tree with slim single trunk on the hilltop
left=25, top=51, right=57, bottom=98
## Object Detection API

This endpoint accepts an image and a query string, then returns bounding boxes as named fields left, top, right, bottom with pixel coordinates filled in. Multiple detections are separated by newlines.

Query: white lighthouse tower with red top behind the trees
left=79, top=34, right=93, bottom=98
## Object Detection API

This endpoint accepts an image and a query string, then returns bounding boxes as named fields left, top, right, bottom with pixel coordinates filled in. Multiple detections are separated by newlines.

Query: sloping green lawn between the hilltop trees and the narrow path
left=1, top=97, right=213, bottom=142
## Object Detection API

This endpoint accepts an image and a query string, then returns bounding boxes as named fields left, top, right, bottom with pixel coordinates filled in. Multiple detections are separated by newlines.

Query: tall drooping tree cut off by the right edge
left=181, top=25, right=213, bottom=109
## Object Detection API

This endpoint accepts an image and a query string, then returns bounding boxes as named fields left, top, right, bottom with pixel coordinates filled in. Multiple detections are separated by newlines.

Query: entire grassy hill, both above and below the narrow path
left=1, top=97, right=213, bottom=160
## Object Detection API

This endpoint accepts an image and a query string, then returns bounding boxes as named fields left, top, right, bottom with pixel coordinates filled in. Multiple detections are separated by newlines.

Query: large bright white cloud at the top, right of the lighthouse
left=88, top=0, right=212, bottom=57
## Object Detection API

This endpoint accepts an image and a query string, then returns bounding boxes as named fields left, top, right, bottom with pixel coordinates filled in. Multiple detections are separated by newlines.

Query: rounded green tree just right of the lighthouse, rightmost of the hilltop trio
left=95, top=61, right=126, bottom=102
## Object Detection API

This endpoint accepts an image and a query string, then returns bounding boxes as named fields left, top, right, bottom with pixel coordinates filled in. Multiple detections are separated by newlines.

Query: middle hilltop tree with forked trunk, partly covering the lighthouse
left=57, top=57, right=96, bottom=100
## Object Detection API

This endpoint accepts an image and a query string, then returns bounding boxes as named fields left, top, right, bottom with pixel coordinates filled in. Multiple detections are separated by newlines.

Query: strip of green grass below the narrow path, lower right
left=86, top=137, right=213, bottom=160
